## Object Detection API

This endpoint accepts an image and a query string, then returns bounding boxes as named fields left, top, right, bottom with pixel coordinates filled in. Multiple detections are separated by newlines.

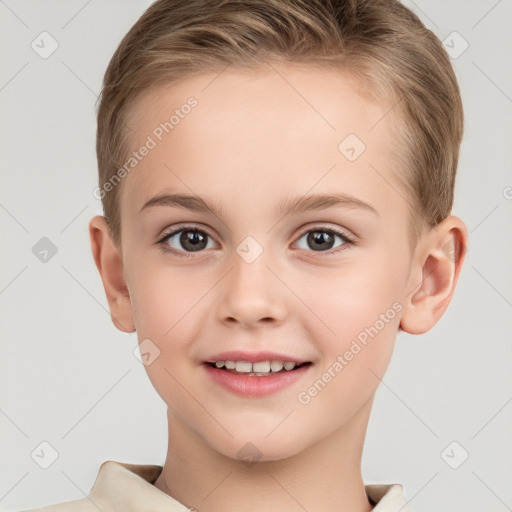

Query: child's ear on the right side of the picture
left=400, top=215, right=468, bottom=334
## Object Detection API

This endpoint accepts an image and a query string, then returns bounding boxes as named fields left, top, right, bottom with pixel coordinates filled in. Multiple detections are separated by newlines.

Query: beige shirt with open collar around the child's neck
left=22, top=460, right=411, bottom=512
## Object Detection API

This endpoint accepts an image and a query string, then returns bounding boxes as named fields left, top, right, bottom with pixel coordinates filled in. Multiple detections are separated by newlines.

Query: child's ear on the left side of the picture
left=89, top=215, right=135, bottom=332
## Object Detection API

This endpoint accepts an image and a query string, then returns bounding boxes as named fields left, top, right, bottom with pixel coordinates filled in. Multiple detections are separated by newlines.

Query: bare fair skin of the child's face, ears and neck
left=90, top=63, right=467, bottom=512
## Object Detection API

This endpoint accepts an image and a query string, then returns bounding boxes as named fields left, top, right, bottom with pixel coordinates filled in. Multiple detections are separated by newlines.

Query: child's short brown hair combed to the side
left=96, top=0, right=463, bottom=247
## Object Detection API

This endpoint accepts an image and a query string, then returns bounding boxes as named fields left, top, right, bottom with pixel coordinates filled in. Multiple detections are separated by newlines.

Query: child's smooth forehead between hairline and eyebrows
left=122, top=63, right=400, bottom=222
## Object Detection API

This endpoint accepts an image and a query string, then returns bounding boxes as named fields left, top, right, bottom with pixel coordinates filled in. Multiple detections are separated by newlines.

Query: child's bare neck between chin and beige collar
left=154, top=399, right=373, bottom=512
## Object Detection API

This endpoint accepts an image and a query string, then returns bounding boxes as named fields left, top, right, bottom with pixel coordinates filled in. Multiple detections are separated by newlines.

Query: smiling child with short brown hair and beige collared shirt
left=26, top=0, right=467, bottom=512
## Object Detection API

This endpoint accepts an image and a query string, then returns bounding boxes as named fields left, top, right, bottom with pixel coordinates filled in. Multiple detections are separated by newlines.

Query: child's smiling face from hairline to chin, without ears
left=112, top=64, right=424, bottom=460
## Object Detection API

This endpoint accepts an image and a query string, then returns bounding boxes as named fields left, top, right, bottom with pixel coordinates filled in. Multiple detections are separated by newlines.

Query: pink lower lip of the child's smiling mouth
left=203, top=363, right=312, bottom=397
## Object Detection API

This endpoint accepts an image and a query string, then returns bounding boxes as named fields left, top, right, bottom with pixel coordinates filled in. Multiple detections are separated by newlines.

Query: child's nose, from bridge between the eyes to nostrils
left=219, top=236, right=285, bottom=326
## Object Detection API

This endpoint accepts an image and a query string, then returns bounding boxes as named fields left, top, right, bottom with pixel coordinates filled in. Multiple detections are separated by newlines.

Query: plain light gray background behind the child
left=0, top=0, right=512, bottom=512
